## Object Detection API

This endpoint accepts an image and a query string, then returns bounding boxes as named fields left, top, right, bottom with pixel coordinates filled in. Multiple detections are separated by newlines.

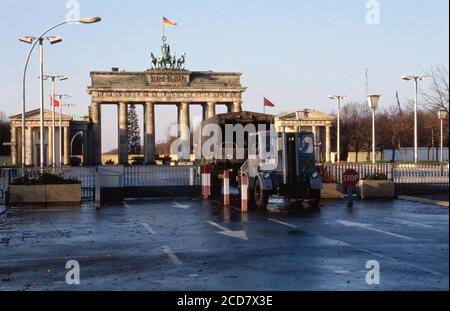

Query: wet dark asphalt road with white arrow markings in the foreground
left=0, top=199, right=449, bottom=291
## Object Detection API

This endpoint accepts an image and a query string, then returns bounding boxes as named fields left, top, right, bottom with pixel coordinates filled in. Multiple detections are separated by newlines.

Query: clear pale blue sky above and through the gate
left=0, top=0, right=449, bottom=149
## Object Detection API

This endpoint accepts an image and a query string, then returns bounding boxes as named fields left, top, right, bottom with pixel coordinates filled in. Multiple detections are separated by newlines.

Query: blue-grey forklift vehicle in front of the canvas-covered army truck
left=241, top=132, right=322, bottom=210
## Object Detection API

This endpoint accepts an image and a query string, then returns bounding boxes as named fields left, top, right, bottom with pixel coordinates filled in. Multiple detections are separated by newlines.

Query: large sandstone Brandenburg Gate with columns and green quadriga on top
left=87, top=39, right=246, bottom=165
